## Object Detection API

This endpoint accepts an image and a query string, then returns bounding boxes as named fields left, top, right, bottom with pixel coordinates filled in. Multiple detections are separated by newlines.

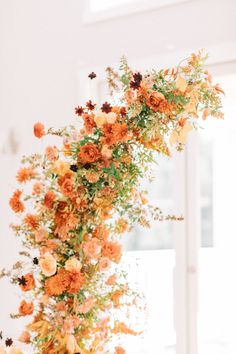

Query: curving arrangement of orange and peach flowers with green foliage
left=0, top=52, right=223, bottom=354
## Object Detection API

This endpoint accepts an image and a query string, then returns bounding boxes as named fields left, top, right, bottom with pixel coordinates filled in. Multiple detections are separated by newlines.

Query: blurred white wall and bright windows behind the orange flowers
left=0, top=0, right=236, bottom=354
